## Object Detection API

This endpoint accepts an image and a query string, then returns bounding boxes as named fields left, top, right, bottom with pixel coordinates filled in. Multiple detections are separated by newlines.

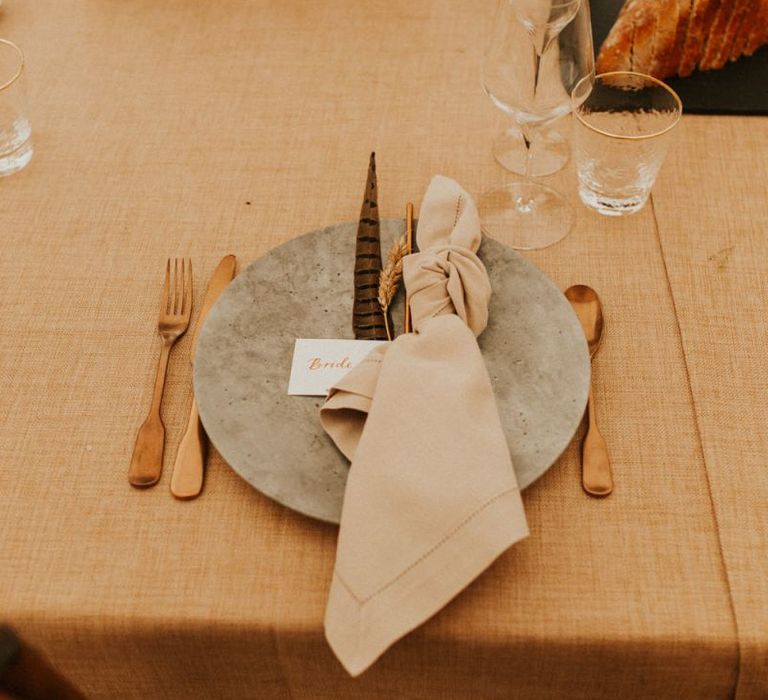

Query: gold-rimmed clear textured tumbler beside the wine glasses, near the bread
left=573, top=72, right=683, bottom=216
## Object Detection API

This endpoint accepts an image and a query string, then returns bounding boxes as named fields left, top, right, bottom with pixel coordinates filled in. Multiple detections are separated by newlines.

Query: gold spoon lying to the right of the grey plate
left=565, top=284, right=613, bottom=497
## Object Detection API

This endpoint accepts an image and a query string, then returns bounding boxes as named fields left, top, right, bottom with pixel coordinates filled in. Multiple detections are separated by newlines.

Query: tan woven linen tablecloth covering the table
left=0, top=0, right=768, bottom=699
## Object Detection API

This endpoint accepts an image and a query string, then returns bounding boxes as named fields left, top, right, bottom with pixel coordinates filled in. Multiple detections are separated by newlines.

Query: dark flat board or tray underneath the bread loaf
left=590, top=0, right=768, bottom=114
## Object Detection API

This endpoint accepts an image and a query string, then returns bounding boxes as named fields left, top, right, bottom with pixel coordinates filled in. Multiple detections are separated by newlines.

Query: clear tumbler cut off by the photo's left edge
left=0, top=39, right=32, bottom=176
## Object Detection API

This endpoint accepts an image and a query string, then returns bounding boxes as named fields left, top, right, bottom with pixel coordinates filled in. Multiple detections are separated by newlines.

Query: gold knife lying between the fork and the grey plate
left=171, top=255, right=237, bottom=500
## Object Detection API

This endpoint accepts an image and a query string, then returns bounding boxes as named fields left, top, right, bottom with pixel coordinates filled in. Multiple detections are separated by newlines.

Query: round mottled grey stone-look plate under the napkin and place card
left=195, top=219, right=590, bottom=523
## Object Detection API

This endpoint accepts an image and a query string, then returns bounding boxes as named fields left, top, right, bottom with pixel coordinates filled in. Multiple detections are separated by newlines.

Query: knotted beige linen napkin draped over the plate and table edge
left=320, top=176, right=528, bottom=676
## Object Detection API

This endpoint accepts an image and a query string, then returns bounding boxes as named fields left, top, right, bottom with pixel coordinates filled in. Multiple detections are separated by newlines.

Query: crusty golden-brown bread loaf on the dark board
left=596, top=0, right=768, bottom=78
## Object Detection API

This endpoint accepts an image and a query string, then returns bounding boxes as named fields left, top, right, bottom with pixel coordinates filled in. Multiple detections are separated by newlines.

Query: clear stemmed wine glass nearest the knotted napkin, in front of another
left=480, top=0, right=595, bottom=250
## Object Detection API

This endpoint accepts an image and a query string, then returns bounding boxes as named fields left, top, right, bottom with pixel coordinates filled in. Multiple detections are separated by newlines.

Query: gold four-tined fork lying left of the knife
left=128, top=258, right=192, bottom=487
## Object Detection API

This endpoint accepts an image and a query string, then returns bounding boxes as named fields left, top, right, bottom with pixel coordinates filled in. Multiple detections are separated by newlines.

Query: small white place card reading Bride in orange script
left=288, top=338, right=387, bottom=396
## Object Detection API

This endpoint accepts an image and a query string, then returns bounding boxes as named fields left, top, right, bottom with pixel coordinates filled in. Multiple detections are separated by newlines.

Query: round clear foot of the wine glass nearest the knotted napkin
left=480, top=182, right=573, bottom=250
